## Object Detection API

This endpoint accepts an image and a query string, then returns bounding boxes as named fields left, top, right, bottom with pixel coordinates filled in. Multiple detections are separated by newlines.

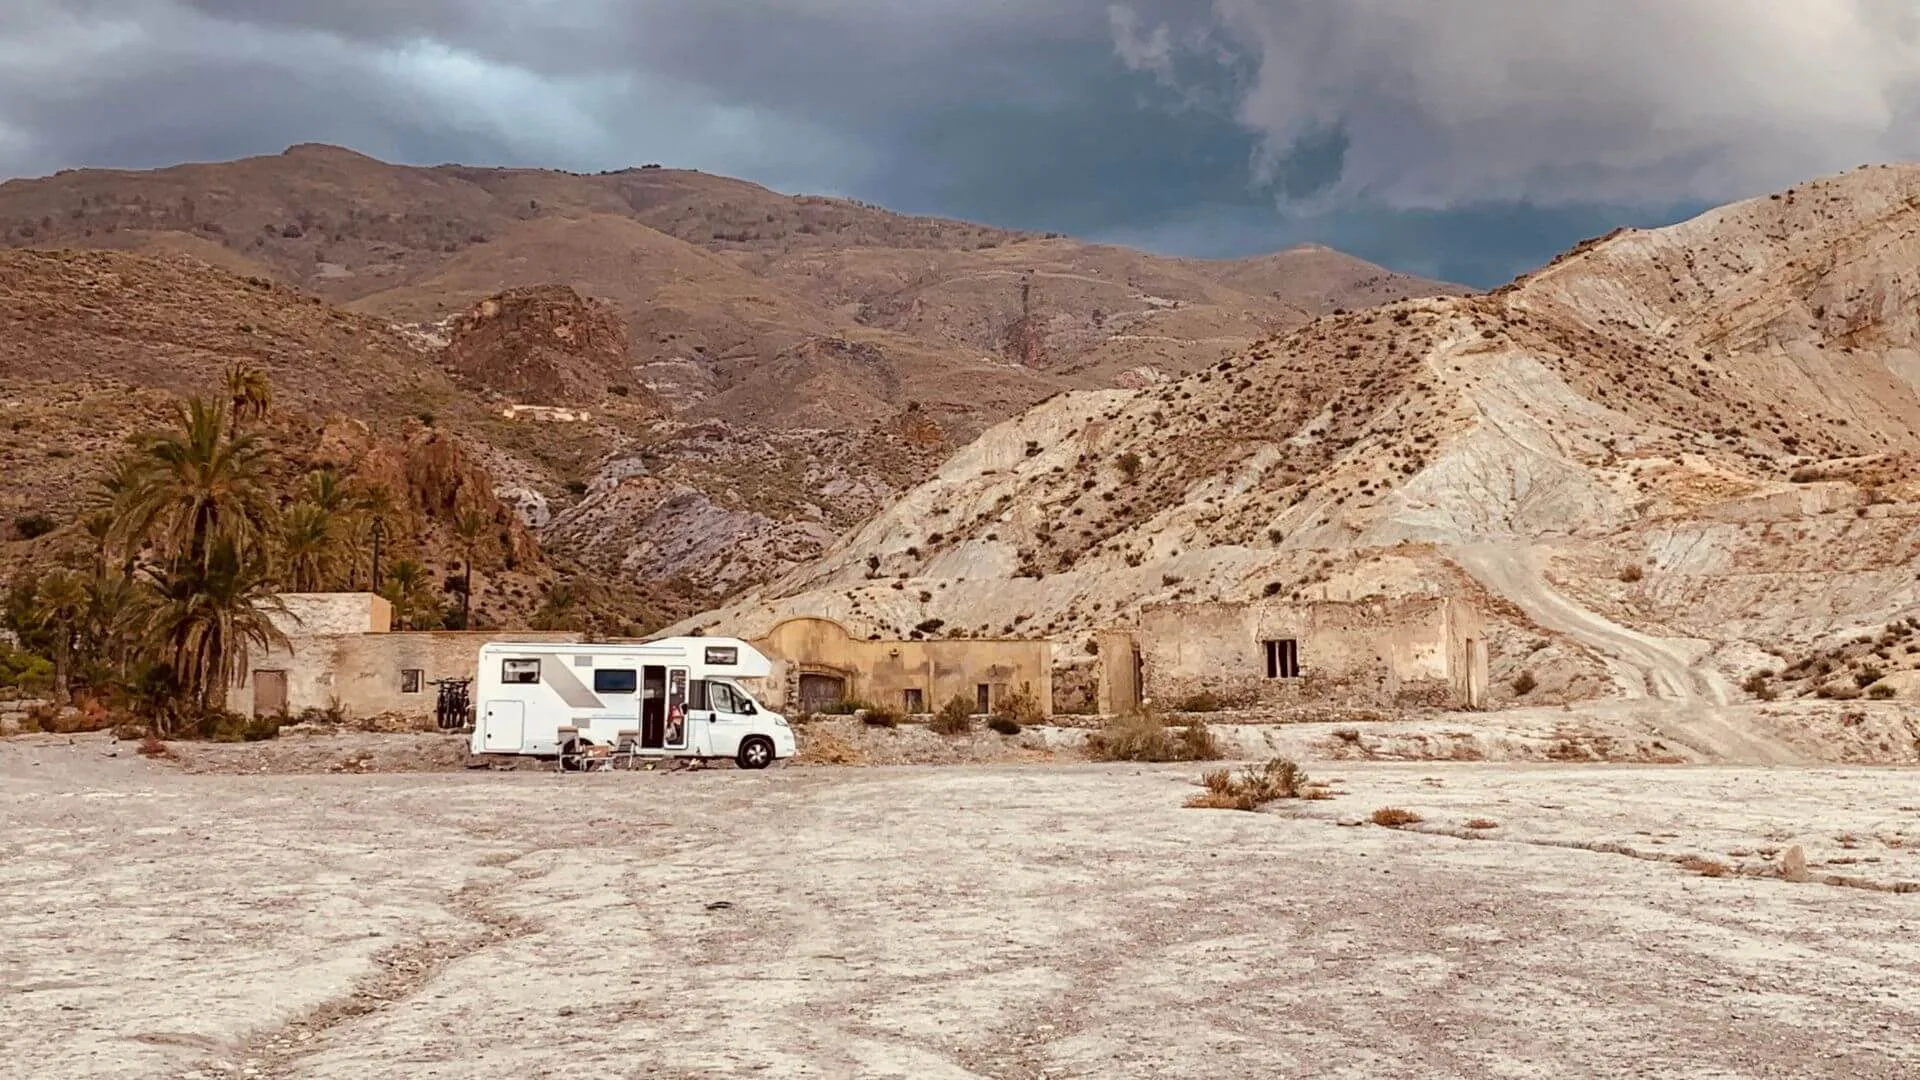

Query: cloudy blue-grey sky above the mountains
left=0, top=0, right=1920, bottom=286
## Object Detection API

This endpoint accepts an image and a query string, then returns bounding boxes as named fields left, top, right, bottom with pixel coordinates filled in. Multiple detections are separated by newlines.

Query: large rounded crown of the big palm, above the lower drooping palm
left=115, top=398, right=276, bottom=571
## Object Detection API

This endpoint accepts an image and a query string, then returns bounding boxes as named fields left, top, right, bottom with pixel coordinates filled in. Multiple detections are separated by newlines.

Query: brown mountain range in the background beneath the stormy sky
left=0, top=146, right=1461, bottom=611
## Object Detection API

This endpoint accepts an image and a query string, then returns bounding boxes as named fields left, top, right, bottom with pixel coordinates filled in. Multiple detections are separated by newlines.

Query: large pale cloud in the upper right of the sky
left=1114, top=0, right=1920, bottom=208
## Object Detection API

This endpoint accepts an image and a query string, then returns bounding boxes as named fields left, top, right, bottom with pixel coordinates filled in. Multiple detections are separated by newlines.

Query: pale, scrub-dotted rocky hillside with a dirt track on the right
left=693, top=167, right=1920, bottom=701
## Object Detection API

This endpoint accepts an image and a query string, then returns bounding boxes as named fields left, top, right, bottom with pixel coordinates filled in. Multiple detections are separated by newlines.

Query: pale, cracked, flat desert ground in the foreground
left=0, top=722, right=1920, bottom=1080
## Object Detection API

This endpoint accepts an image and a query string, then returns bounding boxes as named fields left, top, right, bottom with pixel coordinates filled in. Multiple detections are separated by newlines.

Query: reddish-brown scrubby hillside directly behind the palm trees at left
left=0, top=252, right=651, bottom=625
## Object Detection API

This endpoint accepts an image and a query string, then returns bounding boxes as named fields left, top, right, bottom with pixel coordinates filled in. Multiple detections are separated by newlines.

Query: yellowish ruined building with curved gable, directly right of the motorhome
left=753, top=617, right=1054, bottom=715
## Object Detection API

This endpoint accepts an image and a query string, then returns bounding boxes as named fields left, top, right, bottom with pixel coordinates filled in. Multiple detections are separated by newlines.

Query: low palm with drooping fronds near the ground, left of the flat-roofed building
left=146, top=536, right=286, bottom=709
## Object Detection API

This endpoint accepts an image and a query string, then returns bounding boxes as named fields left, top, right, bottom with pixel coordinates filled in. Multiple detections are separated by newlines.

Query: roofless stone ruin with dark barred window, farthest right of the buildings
left=1096, top=596, right=1488, bottom=713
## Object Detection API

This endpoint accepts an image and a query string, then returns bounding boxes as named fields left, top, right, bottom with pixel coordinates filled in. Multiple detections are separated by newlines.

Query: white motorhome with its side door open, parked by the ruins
left=472, top=638, right=795, bottom=769
